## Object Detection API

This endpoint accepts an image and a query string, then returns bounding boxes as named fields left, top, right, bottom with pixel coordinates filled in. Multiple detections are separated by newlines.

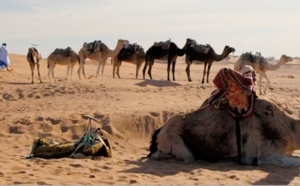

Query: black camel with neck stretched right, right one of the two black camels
left=185, top=39, right=235, bottom=83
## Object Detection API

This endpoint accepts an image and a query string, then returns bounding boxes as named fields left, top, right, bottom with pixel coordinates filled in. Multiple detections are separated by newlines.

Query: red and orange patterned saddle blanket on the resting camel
left=208, top=68, right=256, bottom=118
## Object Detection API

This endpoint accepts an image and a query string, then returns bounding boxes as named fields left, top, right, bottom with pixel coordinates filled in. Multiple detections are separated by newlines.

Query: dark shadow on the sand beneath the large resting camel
left=124, top=159, right=300, bottom=185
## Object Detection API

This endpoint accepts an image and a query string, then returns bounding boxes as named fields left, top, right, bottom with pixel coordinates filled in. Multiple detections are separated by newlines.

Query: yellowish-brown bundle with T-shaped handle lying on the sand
left=27, top=115, right=112, bottom=159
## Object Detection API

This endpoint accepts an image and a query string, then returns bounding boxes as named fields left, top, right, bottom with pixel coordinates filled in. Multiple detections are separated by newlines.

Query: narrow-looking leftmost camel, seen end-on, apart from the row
left=27, top=47, right=42, bottom=83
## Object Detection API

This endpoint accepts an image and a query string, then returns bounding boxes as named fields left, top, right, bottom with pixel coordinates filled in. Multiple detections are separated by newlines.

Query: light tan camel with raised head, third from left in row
left=77, top=39, right=129, bottom=79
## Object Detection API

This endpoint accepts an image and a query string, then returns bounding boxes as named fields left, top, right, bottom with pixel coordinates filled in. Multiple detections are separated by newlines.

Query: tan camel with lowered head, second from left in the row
left=47, top=47, right=79, bottom=82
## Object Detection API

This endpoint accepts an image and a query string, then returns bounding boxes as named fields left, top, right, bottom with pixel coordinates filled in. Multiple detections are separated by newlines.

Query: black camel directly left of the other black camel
left=143, top=40, right=189, bottom=81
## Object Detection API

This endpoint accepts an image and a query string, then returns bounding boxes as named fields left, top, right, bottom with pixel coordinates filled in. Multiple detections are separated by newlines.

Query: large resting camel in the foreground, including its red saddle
left=148, top=66, right=300, bottom=166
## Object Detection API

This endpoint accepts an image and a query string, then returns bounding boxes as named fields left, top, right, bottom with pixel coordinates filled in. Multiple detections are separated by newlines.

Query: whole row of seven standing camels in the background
left=23, top=38, right=293, bottom=87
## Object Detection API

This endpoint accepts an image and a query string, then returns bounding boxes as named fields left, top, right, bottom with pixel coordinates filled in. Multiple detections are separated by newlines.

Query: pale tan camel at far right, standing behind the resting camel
left=234, top=53, right=293, bottom=95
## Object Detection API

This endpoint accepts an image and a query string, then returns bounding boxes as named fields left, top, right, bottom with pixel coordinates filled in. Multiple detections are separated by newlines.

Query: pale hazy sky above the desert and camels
left=0, top=0, right=300, bottom=58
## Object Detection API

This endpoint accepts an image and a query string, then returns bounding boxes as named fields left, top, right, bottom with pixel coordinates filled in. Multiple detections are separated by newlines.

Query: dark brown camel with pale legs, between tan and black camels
left=113, top=43, right=145, bottom=79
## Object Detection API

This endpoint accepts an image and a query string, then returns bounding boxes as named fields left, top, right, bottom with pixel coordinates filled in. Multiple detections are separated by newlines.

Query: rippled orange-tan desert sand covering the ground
left=0, top=54, right=300, bottom=185
